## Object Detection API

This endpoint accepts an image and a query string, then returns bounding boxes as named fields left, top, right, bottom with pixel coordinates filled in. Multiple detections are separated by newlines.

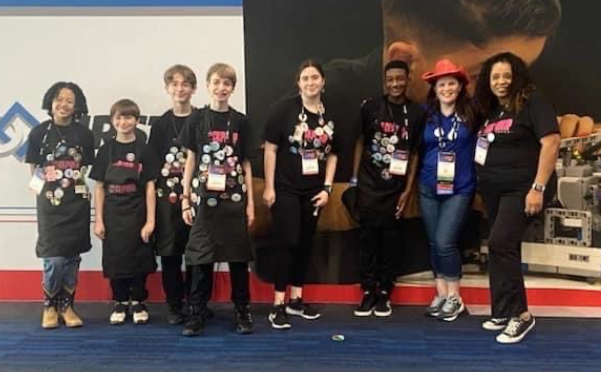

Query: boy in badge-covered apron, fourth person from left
left=180, top=63, right=255, bottom=336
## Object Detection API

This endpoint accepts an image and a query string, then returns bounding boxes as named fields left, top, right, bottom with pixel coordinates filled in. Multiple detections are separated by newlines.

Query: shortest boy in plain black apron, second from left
left=90, top=99, right=157, bottom=325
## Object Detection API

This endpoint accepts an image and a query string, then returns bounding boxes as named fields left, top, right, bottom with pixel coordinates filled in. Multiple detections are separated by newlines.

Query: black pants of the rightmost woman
left=481, top=192, right=532, bottom=318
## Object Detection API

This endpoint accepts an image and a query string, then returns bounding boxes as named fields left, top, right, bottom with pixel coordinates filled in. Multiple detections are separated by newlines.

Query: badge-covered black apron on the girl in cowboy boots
left=36, top=123, right=92, bottom=258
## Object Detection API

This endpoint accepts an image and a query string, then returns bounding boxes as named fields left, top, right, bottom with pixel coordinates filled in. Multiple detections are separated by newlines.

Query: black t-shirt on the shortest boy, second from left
left=90, top=138, right=158, bottom=186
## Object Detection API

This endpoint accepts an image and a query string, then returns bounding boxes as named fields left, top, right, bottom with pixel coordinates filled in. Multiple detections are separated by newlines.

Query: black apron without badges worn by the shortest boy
left=102, top=139, right=157, bottom=279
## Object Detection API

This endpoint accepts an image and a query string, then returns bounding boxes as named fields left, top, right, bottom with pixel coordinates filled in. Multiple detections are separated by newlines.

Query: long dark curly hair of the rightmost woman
left=475, top=52, right=536, bottom=122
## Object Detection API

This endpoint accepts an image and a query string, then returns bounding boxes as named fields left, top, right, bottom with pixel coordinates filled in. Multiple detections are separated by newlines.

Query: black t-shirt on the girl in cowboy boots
left=25, top=120, right=94, bottom=165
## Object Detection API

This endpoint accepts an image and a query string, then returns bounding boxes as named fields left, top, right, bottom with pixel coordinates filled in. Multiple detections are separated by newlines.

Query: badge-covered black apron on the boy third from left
left=155, top=123, right=190, bottom=256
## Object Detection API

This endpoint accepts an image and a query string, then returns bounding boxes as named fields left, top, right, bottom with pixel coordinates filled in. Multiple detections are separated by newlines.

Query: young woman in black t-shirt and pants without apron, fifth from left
left=263, top=60, right=337, bottom=329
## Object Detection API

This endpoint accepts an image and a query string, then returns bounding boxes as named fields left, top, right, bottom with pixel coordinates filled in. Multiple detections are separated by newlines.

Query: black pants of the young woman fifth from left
left=271, top=192, right=318, bottom=292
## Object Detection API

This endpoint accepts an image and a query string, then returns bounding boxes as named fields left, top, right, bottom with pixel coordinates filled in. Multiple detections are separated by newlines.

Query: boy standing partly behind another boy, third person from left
left=148, top=65, right=196, bottom=324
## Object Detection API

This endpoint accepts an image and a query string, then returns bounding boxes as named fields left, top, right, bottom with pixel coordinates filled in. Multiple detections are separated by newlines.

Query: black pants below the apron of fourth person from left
left=188, top=262, right=250, bottom=308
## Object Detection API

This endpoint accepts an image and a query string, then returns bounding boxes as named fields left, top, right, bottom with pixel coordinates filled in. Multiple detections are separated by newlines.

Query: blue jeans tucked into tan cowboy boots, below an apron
left=42, top=255, right=81, bottom=297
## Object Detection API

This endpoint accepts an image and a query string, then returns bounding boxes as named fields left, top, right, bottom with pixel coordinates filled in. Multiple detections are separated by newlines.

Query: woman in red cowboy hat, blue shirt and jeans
left=419, top=59, right=476, bottom=321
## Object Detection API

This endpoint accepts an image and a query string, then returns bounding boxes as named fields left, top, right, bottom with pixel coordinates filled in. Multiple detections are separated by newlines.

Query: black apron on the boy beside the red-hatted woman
left=357, top=98, right=409, bottom=228
